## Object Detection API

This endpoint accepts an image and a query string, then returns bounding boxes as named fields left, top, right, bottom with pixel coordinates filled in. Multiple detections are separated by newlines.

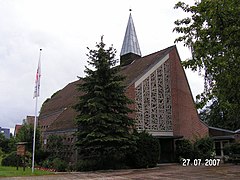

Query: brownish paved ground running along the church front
left=0, top=164, right=240, bottom=180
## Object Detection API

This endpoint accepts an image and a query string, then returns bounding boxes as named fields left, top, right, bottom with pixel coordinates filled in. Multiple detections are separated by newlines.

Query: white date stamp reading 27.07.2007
left=182, top=159, right=220, bottom=166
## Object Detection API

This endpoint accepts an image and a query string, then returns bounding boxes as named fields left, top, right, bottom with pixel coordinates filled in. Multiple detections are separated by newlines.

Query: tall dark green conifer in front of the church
left=75, top=37, right=134, bottom=170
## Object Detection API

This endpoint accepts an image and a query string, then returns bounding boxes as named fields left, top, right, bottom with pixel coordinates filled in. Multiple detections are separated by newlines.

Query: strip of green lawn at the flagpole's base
left=0, top=166, right=53, bottom=177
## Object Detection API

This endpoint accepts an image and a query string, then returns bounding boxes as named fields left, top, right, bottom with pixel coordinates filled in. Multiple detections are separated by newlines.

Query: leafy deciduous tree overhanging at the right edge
left=174, top=0, right=240, bottom=130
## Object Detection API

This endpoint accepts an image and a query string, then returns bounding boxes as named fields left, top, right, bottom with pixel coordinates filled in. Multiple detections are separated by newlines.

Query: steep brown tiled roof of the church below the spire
left=39, top=46, right=176, bottom=131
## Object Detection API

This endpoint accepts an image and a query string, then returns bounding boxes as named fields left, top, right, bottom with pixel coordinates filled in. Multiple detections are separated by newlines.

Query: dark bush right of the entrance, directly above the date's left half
left=176, top=139, right=193, bottom=160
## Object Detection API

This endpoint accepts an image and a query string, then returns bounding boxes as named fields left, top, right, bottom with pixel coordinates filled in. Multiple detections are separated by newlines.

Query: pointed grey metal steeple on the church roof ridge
left=120, top=9, right=142, bottom=65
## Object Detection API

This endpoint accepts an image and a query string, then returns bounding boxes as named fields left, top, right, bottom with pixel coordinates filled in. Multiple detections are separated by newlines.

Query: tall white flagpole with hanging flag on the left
left=32, top=49, right=42, bottom=173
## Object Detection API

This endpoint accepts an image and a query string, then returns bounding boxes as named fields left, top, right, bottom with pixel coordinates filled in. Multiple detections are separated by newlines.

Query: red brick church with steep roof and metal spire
left=39, top=13, right=209, bottom=162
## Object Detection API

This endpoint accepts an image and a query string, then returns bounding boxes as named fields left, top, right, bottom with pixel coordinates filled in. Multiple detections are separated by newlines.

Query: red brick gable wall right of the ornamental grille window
left=169, top=49, right=208, bottom=139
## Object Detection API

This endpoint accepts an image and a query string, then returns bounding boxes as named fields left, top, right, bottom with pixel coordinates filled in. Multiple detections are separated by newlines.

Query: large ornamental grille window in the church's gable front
left=135, top=61, right=172, bottom=131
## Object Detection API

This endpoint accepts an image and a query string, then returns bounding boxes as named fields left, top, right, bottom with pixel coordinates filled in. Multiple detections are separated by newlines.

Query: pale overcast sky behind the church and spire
left=0, top=0, right=203, bottom=132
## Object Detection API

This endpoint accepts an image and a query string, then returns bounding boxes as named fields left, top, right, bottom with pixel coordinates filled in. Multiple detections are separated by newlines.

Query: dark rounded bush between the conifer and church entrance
left=127, top=132, right=160, bottom=168
